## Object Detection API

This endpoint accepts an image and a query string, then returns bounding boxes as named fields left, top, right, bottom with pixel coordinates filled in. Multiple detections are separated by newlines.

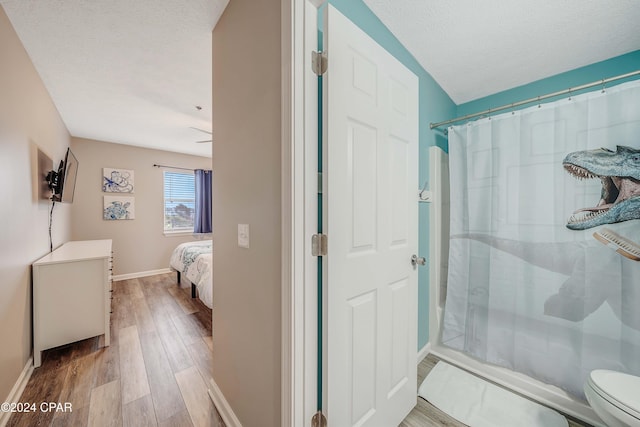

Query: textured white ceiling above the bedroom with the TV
left=0, top=0, right=228, bottom=157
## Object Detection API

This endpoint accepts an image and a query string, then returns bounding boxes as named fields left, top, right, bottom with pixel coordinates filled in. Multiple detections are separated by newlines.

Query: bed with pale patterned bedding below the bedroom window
left=169, top=240, right=213, bottom=308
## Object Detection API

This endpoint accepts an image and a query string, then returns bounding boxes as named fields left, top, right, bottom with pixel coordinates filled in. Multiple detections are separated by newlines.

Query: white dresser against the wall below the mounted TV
left=33, top=240, right=112, bottom=368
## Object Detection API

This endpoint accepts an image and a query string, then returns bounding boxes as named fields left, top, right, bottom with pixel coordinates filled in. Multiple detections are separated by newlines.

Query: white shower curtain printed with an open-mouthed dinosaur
left=441, top=78, right=640, bottom=398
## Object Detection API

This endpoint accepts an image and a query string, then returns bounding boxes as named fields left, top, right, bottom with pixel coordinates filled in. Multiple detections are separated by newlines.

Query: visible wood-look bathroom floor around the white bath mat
left=399, top=354, right=591, bottom=427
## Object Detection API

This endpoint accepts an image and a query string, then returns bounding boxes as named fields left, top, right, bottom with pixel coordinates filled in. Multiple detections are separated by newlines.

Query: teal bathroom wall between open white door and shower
left=329, top=0, right=456, bottom=349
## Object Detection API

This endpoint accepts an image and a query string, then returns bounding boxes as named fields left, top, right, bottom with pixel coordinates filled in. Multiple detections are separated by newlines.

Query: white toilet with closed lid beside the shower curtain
left=584, top=369, right=640, bottom=427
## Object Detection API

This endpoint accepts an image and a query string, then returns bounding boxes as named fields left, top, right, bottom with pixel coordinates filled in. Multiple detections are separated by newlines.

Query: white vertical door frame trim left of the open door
left=281, top=0, right=325, bottom=427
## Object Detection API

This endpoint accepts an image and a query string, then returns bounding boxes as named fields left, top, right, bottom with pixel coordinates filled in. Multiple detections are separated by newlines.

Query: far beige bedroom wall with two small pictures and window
left=71, top=138, right=211, bottom=275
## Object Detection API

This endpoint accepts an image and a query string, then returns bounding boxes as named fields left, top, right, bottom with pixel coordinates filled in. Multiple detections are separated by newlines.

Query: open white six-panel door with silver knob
left=323, top=5, right=418, bottom=427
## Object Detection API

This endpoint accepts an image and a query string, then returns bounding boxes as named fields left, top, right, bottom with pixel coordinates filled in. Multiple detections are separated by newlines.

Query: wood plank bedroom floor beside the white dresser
left=8, top=274, right=224, bottom=427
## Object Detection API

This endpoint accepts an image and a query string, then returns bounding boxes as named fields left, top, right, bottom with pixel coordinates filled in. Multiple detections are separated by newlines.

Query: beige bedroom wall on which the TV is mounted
left=0, top=6, right=70, bottom=402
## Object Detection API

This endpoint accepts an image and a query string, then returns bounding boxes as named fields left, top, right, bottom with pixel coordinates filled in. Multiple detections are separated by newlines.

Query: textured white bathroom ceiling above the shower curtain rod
left=364, top=0, right=640, bottom=104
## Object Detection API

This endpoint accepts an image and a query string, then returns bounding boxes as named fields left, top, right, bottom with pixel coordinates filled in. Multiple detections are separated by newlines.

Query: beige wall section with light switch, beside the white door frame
left=213, top=0, right=281, bottom=427
